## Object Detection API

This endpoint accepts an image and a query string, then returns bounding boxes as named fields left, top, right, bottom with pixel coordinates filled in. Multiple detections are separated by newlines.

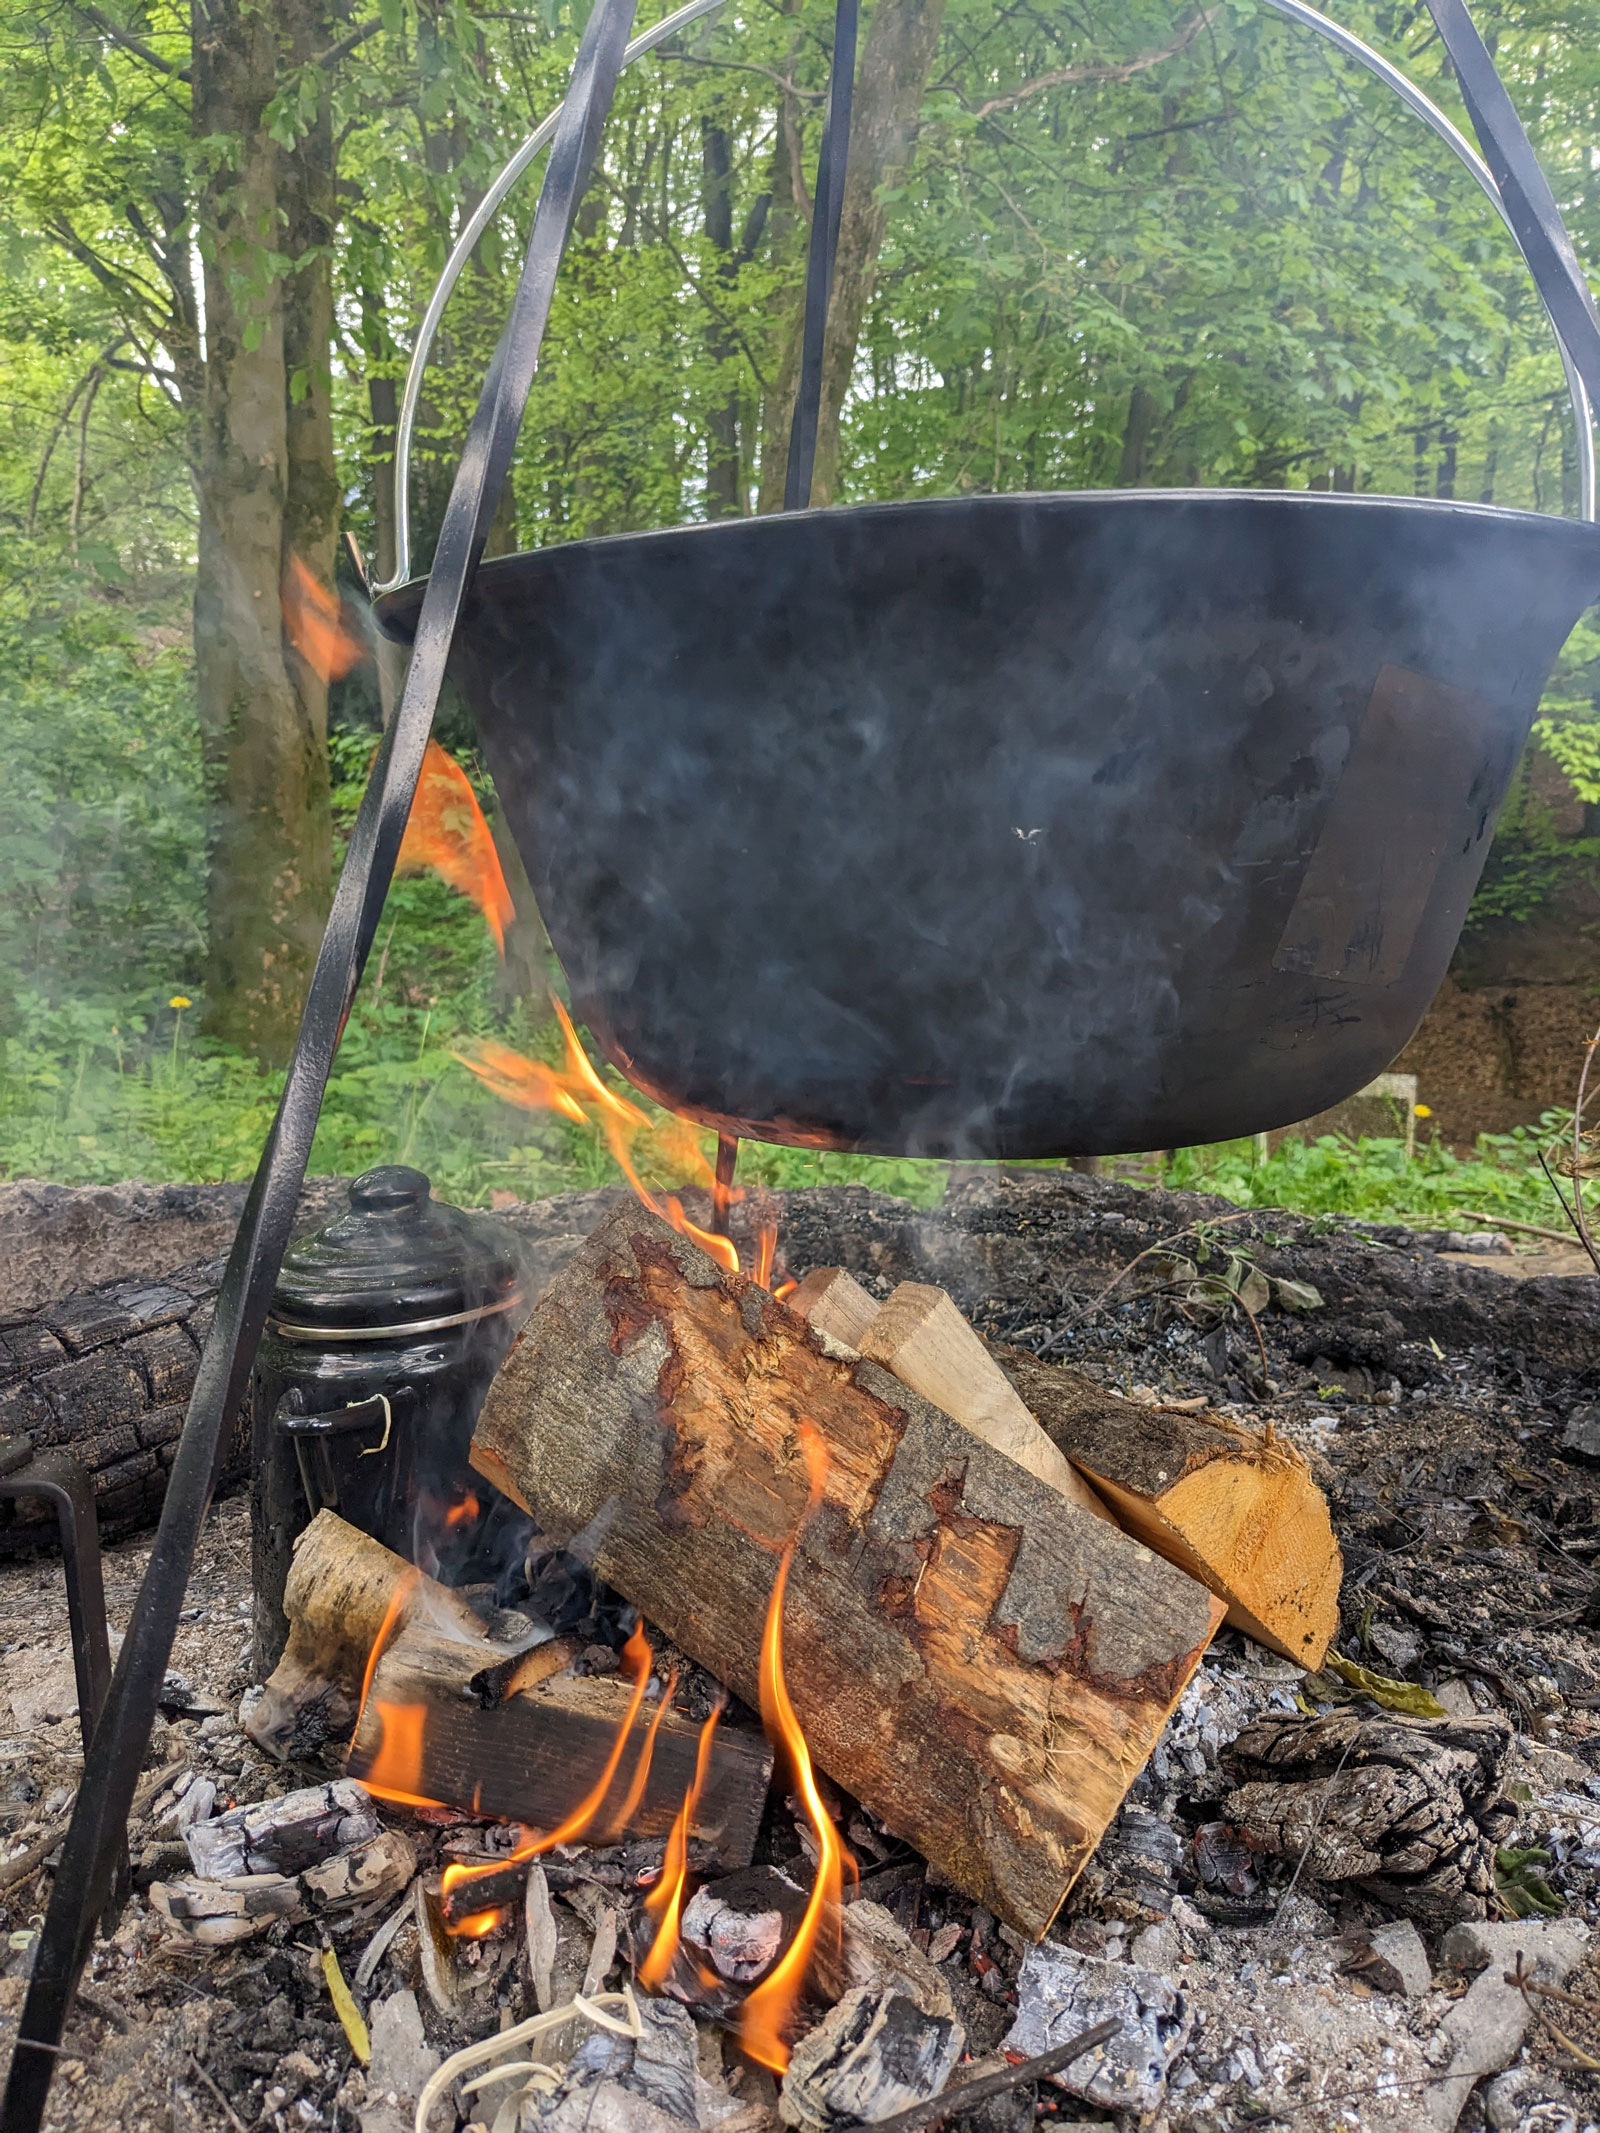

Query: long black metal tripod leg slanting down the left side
left=0, top=0, right=634, bottom=2133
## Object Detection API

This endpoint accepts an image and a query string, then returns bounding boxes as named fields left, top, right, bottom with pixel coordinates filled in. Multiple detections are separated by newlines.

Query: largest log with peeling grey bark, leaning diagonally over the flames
left=471, top=1207, right=1225, bottom=1937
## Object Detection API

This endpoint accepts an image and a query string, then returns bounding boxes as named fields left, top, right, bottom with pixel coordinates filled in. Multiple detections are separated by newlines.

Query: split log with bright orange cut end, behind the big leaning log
left=1001, top=1348, right=1344, bottom=1670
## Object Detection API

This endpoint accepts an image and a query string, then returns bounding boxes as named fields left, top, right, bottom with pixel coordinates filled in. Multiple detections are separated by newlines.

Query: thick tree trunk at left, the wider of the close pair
left=192, top=0, right=329, bottom=1060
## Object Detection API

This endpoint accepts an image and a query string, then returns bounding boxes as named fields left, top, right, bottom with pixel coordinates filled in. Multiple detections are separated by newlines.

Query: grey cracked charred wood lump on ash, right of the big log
left=1222, top=1709, right=1517, bottom=1926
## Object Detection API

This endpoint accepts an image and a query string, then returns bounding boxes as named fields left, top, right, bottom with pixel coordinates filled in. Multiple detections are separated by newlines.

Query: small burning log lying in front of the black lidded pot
left=245, top=1510, right=772, bottom=1869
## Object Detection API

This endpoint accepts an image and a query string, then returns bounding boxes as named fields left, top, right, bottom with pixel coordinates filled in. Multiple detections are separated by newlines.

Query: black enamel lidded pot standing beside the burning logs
left=252, top=1165, right=525, bottom=1677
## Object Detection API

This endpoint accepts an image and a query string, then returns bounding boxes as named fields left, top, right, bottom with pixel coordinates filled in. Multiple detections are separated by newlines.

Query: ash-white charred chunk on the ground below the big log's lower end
left=1001, top=1941, right=1193, bottom=2116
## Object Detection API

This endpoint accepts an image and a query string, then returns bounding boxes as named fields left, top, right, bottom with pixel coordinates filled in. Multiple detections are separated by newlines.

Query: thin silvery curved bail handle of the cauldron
left=373, top=0, right=1596, bottom=593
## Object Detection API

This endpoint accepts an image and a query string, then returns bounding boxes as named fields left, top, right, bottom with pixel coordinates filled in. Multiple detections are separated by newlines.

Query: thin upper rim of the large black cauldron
left=373, top=475, right=1600, bottom=622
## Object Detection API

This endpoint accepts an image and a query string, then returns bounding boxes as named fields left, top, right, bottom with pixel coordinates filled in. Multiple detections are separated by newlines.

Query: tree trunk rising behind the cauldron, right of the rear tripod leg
left=811, top=0, right=945, bottom=503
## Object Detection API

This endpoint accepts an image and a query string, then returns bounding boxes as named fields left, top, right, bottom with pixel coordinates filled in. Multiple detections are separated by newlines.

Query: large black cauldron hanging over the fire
left=378, top=491, right=1600, bottom=1158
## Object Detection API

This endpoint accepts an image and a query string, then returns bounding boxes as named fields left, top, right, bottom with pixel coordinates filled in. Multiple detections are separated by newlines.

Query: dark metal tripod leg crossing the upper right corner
left=1427, top=0, right=1600, bottom=407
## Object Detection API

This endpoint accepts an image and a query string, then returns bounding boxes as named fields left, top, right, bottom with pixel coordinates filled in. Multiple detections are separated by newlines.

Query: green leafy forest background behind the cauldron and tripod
left=0, top=0, right=1600, bottom=1220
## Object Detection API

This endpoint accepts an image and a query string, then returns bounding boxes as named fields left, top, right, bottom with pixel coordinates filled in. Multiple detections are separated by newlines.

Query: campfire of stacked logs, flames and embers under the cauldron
left=109, top=1151, right=1340, bottom=2127
